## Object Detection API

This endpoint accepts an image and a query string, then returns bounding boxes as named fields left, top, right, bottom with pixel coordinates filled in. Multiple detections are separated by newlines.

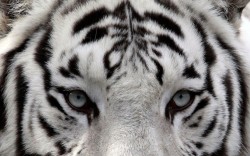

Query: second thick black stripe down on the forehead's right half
left=153, top=35, right=185, bottom=56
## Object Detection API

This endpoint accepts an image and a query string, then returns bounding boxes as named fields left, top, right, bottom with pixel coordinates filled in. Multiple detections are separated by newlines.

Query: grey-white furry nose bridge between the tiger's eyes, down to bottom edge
left=105, top=88, right=163, bottom=156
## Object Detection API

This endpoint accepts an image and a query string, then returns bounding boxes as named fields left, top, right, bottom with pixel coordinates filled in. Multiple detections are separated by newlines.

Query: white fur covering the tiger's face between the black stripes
left=0, top=0, right=250, bottom=156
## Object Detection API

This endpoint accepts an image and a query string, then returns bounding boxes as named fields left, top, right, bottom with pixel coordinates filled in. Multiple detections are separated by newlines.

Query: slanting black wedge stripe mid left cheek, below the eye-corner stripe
left=38, top=113, right=59, bottom=137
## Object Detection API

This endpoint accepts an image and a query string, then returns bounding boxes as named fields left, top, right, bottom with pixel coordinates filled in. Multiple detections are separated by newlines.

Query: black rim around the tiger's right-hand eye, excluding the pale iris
left=166, top=89, right=196, bottom=116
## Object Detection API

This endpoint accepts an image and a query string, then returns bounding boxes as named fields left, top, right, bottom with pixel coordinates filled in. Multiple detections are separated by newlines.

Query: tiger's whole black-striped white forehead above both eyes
left=50, top=0, right=207, bottom=89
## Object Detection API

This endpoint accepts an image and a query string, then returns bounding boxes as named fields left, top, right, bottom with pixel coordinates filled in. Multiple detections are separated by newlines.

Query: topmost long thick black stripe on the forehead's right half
left=145, top=12, right=184, bottom=38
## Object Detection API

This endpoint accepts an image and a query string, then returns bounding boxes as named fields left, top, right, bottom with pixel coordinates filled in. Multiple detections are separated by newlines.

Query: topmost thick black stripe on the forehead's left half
left=73, top=8, right=109, bottom=35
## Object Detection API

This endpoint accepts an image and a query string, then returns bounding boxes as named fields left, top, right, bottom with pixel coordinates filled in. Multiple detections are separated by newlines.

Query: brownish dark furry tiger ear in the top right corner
left=212, top=0, right=250, bottom=28
